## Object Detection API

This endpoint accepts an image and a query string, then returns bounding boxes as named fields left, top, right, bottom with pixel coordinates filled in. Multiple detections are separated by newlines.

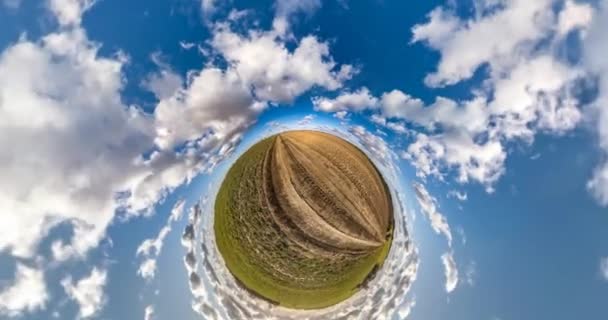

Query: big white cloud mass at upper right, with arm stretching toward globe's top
left=313, top=0, right=592, bottom=192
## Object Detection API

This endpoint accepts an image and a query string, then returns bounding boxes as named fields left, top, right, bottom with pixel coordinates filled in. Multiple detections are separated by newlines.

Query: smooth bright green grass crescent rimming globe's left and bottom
left=214, top=136, right=392, bottom=309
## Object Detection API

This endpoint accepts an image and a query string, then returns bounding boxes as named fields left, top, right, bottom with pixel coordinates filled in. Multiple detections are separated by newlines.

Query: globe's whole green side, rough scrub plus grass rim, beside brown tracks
left=214, top=131, right=392, bottom=309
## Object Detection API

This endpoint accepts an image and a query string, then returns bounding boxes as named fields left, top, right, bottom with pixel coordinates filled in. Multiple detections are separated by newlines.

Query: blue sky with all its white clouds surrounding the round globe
left=0, top=0, right=608, bottom=320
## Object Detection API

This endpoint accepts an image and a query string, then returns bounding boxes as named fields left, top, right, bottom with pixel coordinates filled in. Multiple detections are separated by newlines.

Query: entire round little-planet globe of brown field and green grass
left=214, top=131, right=392, bottom=309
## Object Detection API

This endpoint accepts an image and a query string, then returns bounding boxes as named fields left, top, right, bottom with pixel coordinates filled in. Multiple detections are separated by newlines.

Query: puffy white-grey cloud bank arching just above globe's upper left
left=155, top=17, right=352, bottom=154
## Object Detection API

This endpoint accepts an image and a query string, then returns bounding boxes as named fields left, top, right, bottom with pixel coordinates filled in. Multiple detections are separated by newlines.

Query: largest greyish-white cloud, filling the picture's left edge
left=0, top=28, right=153, bottom=257
